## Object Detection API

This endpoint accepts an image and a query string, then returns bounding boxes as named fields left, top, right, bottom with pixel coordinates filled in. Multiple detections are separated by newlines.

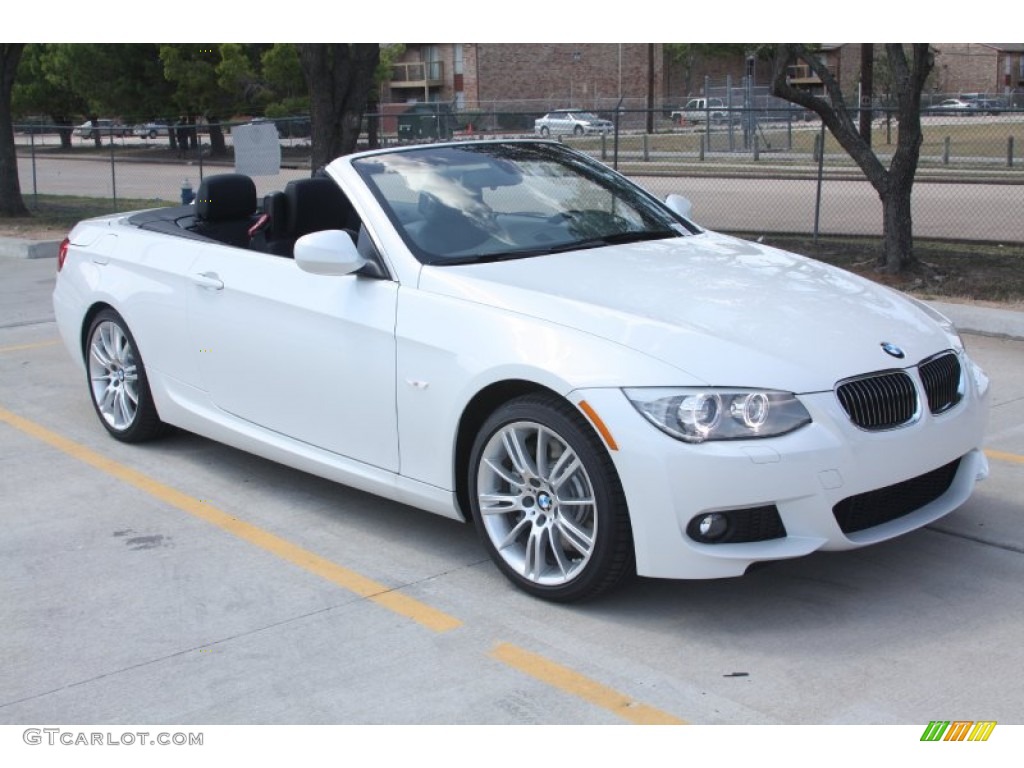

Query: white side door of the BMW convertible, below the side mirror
left=189, top=247, right=398, bottom=471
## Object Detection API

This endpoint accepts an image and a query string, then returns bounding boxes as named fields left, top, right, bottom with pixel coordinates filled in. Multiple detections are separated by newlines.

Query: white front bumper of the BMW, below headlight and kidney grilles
left=573, top=355, right=988, bottom=579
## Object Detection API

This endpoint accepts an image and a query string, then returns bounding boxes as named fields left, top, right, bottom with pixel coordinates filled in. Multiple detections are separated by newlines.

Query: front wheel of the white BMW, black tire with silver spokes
left=468, top=394, right=635, bottom=602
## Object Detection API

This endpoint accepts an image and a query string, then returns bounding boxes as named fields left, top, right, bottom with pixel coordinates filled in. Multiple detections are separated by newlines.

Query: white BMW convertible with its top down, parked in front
left=53, top=141, right=988, bottom=601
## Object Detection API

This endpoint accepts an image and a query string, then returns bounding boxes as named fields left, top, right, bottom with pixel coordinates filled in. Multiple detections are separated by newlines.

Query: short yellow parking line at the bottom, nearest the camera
left=490, top=643, right=686, bottom=725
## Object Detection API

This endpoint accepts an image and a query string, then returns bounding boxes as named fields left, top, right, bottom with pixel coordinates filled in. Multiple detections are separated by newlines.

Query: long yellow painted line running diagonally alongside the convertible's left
left=0, top=408, right=462, bottom=632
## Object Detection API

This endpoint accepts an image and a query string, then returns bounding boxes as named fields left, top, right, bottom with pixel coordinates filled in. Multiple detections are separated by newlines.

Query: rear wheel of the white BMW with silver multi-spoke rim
left=85, top=309, right=167, bottom=442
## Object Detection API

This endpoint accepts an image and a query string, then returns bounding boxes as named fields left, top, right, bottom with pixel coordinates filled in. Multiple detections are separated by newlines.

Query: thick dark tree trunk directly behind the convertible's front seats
left=299, top=43, right=381, bottom=168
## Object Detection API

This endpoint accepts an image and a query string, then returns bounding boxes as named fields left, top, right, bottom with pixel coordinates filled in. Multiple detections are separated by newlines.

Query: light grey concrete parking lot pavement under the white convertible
left=0, top=260, right=1024, bottom=728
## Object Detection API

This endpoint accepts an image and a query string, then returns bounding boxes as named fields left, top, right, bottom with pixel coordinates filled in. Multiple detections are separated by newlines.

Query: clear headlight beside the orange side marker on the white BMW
left=623, top=387, right=811, bottom=442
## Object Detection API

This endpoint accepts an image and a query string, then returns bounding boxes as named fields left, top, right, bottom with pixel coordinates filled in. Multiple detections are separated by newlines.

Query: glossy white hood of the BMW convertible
left=420, top=232, right=952, bottom=393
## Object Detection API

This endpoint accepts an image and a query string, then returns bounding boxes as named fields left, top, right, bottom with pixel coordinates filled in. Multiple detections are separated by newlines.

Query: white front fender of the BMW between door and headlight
left=396, top=290, right=699, bottom=489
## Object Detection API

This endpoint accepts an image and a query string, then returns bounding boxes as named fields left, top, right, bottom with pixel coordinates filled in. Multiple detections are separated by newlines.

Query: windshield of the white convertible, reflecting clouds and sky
left=352, top=141, right=693, bottom=264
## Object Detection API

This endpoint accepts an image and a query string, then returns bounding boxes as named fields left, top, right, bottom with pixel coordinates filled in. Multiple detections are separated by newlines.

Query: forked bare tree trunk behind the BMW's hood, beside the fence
left=772, top=43, right=934, bottom=272
